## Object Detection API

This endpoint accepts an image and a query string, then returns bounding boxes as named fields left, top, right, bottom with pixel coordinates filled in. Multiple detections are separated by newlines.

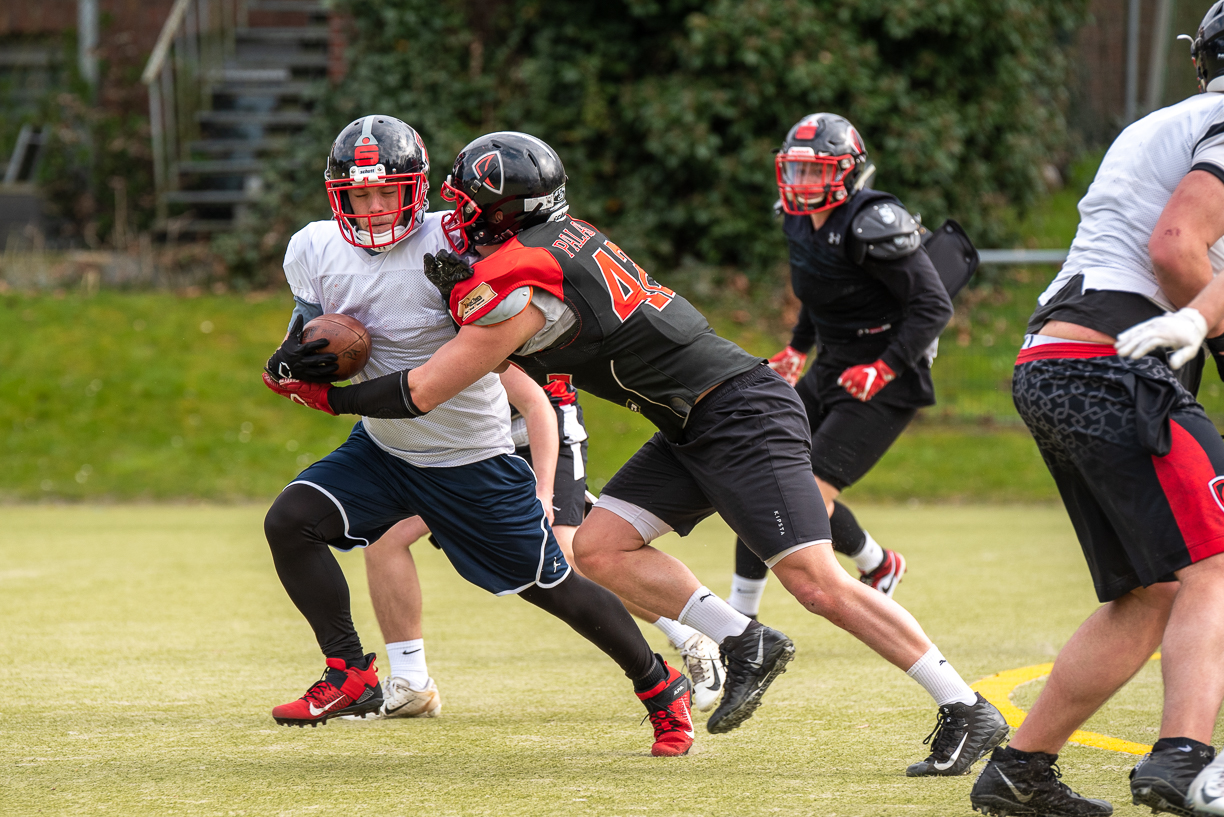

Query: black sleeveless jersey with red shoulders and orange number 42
left=449, top=217, right=761, bottom=440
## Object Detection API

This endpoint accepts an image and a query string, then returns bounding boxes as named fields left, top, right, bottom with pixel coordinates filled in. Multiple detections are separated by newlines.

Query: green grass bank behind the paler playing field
left=0, top=292, right=1053, bottom=501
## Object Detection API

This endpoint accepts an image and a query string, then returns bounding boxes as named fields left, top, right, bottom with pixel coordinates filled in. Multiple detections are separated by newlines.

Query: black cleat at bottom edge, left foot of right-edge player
left=969, top=748, right=1114, bottom=817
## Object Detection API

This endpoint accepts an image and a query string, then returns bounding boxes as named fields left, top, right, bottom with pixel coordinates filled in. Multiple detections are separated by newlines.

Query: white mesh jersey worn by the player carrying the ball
left=285, top=213, right=514, bottom=468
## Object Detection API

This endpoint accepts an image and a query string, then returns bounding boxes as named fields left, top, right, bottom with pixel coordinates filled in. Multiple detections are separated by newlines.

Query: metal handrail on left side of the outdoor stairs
left=141, top=0, right=247, bottom=222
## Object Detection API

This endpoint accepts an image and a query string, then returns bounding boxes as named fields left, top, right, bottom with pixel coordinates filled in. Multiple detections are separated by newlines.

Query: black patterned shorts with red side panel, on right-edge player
left=1012, top=342, right=1224, bottom=601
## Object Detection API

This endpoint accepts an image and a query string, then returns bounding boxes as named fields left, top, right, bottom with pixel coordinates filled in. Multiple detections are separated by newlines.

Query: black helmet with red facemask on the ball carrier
left=323, top=114, right=430, bottom=252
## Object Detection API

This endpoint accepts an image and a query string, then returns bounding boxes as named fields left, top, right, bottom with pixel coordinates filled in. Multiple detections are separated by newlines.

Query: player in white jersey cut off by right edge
left=971, top=8, right=1224, bottom=817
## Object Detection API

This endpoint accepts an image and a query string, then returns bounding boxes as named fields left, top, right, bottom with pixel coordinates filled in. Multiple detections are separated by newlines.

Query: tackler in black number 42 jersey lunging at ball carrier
left=272, top=132, right=1007, bottom=775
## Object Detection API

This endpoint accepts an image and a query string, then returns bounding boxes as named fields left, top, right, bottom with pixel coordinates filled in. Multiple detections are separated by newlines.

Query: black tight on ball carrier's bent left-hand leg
left=263, top=485, right=362, bottom=661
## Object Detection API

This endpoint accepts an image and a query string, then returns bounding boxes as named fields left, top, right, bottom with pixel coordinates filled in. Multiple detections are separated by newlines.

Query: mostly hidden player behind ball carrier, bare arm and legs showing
left=354, top=374, right=723, bottom=718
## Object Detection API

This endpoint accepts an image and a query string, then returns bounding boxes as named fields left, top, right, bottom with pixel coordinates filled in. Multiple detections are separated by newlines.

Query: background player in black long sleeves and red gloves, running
left=731, top=114, right=952, bottom=615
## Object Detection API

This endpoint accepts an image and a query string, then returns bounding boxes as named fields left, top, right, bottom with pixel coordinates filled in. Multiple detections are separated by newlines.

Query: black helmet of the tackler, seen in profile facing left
left=441, top=131, right=569, bottom=254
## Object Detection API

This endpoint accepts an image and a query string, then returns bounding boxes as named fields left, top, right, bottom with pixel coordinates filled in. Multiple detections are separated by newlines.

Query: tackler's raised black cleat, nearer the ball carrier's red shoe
left=705, top=621, right=794, bottom=735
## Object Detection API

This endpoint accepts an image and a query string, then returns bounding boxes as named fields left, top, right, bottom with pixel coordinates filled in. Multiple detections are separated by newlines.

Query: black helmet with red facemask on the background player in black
left=774, top=116, right=871, bottom=216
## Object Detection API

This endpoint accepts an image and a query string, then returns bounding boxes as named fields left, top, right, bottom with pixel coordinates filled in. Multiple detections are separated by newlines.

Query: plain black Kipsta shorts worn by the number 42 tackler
left=599, top=365, right=831, bottom=566
